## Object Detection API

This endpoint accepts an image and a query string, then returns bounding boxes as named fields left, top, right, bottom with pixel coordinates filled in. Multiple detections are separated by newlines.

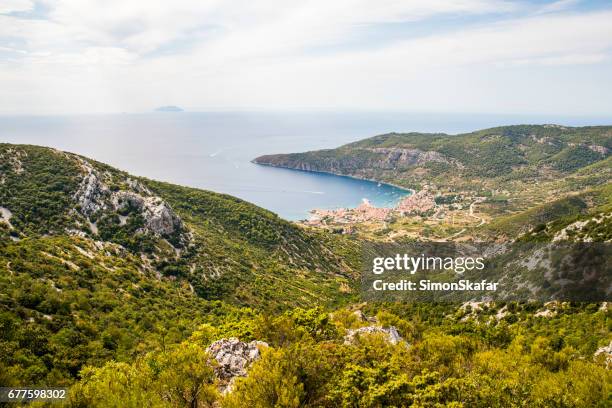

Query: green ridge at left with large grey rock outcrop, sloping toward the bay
left=0, top=144, right=358, bottom=308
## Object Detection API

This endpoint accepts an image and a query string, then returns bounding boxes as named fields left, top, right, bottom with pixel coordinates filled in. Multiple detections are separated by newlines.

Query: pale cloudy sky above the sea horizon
left=0, top=0, right=612, bottom=115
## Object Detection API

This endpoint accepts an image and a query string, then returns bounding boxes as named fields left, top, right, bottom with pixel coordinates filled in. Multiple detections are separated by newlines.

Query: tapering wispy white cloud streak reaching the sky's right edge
left=362, top=12, right=612, bottom=66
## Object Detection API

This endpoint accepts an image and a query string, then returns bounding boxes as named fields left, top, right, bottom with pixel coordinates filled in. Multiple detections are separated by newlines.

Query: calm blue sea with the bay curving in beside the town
left=0, top=112, right=612, bottom=220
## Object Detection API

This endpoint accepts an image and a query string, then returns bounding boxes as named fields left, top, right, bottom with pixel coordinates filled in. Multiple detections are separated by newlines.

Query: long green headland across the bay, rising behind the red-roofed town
left=254, top=125, right=612, bottom=189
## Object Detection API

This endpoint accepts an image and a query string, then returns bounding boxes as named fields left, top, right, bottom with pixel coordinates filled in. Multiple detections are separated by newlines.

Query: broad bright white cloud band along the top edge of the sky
left=2, top=0, right=514, bottom=53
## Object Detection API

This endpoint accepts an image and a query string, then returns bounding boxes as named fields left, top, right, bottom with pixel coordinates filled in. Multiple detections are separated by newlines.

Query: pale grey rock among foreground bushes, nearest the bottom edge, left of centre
left=206, top=337, right=268, bottom=393
